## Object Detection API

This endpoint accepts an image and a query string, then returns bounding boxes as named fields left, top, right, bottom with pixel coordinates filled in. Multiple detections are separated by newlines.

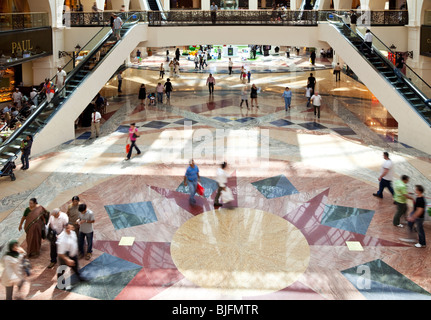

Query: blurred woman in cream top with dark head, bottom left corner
left=1, top=240, right=26, bottom=300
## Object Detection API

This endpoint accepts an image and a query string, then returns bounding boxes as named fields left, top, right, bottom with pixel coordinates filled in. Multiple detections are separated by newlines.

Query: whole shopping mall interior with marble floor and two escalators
left=0, top=0, right=431, bottom=303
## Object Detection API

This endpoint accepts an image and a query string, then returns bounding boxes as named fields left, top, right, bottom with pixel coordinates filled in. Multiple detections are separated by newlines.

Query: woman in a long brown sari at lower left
left=18, top=198, right=49, bottom=258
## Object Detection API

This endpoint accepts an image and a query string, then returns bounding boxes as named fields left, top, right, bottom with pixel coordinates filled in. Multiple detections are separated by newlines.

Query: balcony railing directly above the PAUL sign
left=0, top=12, right=50, bottom=32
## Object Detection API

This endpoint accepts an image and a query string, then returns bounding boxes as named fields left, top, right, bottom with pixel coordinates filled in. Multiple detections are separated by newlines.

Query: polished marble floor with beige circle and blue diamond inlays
left=0, top=50, right=431, bottom=300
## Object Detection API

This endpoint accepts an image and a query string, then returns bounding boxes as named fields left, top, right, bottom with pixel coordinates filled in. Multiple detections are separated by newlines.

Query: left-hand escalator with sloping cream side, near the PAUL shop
left=0, top=15, right=145, bottom=165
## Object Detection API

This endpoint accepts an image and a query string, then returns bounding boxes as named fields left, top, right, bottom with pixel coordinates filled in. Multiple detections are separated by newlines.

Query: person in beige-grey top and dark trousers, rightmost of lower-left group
left=78, top=203, right=95, bottom=260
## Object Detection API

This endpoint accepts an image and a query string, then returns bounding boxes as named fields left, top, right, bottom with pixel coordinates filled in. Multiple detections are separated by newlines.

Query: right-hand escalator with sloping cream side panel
left=319, top=13, right=431, bottom=153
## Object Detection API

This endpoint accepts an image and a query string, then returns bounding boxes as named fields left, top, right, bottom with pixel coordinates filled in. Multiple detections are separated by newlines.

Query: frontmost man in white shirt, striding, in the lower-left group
left=57, top=223, right=84, bottom=289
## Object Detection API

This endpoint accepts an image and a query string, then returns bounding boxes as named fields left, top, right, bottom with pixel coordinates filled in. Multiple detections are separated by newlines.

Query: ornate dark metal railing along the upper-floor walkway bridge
left=61, top=9, right=408, bottom=27
